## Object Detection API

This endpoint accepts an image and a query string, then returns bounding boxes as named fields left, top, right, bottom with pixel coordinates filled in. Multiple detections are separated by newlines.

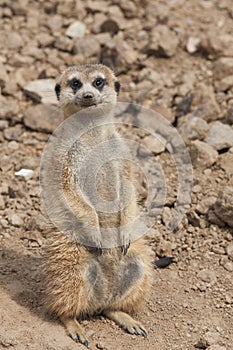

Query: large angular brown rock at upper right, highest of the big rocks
left=143, top=25, right=179, bottom=57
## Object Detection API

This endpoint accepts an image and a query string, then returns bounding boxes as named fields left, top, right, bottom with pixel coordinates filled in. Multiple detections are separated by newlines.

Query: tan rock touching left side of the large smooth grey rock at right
left=178, top=113, right=209, bottom=142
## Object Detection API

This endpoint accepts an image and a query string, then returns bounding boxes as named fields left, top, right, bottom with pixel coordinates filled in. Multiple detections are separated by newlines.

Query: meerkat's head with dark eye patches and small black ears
left=55, top=64, right=120, bottom=116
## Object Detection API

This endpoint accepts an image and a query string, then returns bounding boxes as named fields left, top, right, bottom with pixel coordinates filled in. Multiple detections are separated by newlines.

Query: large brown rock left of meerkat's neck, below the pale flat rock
left=23, top=104, right=64, bottom=133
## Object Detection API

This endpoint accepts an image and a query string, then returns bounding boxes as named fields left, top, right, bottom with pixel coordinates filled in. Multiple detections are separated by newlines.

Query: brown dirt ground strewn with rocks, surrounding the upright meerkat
left=0, top=0, right=233, bottom=350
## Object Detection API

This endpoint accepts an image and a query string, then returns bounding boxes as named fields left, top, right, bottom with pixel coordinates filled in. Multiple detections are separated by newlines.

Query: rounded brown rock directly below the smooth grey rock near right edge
left=190, top=140, right=218, bottom=169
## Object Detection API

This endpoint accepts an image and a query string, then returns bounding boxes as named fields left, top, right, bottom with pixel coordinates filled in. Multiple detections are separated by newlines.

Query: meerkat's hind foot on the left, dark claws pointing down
left=60, top=317, right=89, bottom=347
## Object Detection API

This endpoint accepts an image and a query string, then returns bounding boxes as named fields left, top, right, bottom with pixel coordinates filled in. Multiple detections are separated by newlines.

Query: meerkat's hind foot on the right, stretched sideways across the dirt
left=104, top=311, right=147, bottom=337
